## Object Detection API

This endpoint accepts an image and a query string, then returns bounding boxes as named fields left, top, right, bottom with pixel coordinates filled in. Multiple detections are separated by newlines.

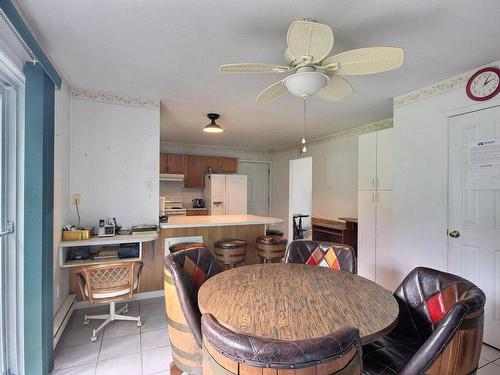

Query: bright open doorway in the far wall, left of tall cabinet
left=288, top=157, right=312, bottom=239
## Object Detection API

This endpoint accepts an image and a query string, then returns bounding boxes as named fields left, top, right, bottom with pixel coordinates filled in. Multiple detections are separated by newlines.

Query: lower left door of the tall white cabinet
left=358, top=190, right=377, bottom=281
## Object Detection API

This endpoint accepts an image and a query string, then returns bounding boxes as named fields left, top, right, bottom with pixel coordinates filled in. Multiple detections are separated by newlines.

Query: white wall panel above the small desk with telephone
left=70, top=97, right=160, bottom=227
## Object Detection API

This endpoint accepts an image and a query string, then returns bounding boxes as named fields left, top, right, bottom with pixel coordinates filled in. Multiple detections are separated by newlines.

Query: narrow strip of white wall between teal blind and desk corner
left=54, top=83, right=71, bottom=315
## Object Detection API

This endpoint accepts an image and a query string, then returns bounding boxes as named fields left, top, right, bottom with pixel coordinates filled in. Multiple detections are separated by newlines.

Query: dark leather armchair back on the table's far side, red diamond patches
left=285, top=240, right=356, bottom=273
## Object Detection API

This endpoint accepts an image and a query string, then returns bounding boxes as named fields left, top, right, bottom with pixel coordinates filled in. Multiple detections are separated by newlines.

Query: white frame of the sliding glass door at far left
left=0, top=51, right=24, bottom=374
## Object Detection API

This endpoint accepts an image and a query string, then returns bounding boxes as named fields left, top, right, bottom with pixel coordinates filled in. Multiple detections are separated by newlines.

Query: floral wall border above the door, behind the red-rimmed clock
left=394, top=61, right=500, bottom=107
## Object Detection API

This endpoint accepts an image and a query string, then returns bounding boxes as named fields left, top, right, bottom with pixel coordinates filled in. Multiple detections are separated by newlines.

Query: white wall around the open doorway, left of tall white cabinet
left=272, top=135, right=358, bottom=238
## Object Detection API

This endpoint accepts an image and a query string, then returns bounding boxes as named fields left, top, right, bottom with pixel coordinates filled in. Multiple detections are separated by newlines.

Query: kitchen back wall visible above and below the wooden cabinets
left=160, top=143, right=271, bottom=205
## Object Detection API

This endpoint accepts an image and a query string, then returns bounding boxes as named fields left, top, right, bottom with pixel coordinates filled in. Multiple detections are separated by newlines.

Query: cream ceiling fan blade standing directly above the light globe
left=286, top=21, right=333, bottom=63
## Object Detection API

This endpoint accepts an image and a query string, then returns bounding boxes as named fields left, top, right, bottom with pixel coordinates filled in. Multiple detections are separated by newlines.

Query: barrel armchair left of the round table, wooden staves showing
left=164, top=246, right=220, bottom=375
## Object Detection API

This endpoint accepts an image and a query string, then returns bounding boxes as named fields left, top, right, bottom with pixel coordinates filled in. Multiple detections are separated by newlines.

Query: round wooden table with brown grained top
left=198, top=263, right=398, bottom=344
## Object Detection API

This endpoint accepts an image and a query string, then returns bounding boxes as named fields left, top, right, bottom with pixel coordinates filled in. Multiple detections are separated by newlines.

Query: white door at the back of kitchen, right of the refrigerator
left=239, top=161, right=270, bottom=216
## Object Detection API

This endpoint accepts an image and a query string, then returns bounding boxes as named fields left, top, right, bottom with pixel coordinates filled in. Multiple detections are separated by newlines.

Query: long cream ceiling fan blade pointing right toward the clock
left=322, top=47, right=404, bottom=75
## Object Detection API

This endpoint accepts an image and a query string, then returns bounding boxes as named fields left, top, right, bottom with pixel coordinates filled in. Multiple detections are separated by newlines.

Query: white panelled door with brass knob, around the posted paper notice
left=448, top=107, right=500, bottom=348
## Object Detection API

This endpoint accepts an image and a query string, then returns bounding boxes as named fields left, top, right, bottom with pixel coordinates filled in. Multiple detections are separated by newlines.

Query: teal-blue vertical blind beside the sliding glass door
left=24, top=63, right=55, bottom=375
